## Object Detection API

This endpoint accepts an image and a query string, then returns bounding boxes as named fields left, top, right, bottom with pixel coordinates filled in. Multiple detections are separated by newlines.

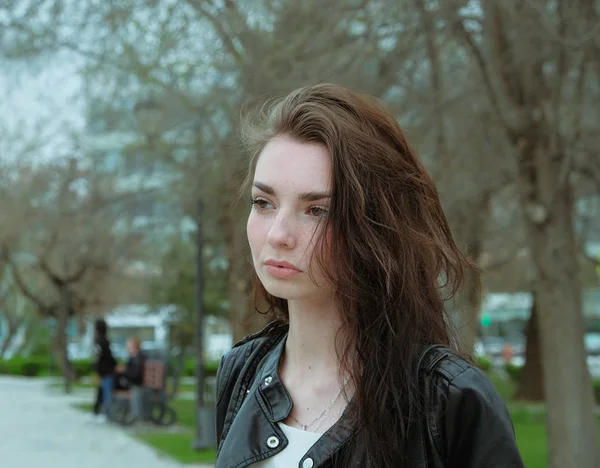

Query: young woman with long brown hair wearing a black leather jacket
left=216, top=84, right=523, bottom=468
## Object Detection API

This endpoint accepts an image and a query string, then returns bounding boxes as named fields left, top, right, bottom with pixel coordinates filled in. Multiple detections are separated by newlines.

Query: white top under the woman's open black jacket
left=250, top=423, right=323, bottom=468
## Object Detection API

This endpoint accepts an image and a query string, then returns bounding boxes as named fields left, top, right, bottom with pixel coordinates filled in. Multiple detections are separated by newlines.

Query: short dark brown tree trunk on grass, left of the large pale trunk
left=515, top=293, right=545, bottom=401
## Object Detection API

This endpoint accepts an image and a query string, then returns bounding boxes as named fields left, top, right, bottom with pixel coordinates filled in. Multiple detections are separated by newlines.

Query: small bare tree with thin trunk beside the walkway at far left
left=4, top=159, right=146, bottom=387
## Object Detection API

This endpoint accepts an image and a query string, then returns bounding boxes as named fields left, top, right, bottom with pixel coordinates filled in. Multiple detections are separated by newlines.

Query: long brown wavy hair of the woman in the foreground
left=244, top=84, right=473, bottom=468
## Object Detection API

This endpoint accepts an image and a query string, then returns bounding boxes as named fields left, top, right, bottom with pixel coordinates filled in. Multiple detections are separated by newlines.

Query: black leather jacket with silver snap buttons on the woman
left=215, top=324, right=524, bottom=468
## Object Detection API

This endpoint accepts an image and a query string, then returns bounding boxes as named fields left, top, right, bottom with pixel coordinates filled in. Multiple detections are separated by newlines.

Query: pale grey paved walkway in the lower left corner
left=0, top=377, right=209, bottom=468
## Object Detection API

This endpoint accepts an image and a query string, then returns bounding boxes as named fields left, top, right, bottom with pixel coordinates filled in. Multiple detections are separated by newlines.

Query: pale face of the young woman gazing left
left=247, top=136, right=332, bottom=300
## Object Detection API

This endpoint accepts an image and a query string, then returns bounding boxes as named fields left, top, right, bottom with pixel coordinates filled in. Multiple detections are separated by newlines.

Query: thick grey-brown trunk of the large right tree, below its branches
left=518, top=143, right=600, bottom=468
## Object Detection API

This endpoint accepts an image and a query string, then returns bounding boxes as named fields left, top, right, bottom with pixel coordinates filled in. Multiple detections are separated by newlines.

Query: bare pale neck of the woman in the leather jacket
left=281, top=301, right=341, bottom=382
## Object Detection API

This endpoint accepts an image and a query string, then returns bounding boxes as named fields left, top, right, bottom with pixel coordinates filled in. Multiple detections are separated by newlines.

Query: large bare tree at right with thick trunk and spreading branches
left=440, top=0, right=599, bottom=467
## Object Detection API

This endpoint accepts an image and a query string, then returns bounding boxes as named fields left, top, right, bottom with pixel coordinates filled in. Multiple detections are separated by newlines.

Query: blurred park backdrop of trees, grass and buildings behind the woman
left=0, top=0, right=600, bottom=468
